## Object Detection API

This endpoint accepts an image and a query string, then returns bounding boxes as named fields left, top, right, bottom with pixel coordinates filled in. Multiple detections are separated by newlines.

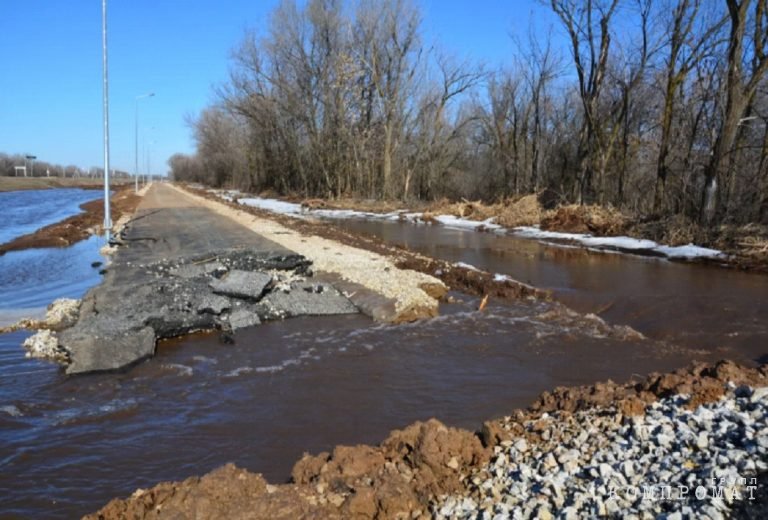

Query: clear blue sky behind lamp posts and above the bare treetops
left=0, top=0, right=552, bottom=174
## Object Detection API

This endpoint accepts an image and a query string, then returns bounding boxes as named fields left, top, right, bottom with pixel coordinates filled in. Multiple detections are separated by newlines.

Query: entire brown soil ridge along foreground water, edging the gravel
left=86, top=361, right=768, bottom=519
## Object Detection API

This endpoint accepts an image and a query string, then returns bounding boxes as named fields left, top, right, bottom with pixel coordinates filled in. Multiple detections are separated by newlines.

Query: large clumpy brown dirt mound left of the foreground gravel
left=90, top=419, right=490, bottom=520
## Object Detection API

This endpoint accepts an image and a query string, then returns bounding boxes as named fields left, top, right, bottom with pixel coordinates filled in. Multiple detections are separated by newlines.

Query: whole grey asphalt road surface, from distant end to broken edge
left=59, top=185, right=358, bottom=374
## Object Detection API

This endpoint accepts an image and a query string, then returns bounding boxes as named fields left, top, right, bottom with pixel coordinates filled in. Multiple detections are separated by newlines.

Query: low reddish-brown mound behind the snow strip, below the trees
left=541, top=204, right=627, bottom=236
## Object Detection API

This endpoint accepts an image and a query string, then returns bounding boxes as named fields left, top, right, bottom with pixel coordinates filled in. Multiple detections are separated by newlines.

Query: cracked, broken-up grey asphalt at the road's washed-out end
left=60, top=250, right=358, bottom=374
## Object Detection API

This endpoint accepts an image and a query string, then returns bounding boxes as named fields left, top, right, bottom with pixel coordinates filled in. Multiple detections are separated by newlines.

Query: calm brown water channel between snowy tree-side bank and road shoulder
left=334, top=220, right=768, bottom=360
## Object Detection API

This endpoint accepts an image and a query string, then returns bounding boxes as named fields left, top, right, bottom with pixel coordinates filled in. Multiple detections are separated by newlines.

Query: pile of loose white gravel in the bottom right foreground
left=433, top=387, right=768, bottom=519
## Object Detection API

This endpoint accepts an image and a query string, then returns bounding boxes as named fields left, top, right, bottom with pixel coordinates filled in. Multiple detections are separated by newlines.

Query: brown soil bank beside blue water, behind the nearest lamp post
left=0, top=188, right=141, bottom=255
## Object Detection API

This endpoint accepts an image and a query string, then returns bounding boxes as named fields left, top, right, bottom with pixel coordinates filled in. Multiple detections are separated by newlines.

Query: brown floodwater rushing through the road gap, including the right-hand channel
left=0, top=192, right=768, bottom=518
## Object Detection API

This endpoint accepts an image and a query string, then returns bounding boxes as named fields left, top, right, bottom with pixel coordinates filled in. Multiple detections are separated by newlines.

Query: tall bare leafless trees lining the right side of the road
left=169, top=0, right=768, bottom=224
